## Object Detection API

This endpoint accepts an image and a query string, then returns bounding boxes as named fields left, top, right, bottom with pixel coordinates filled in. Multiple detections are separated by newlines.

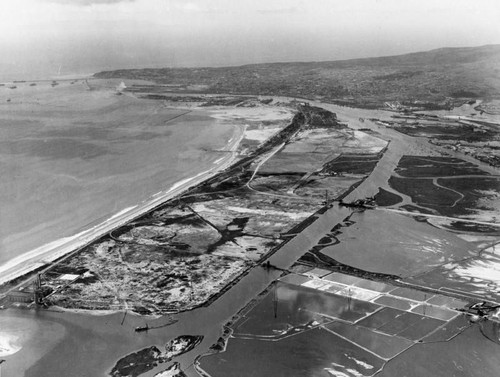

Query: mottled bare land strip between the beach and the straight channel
left=41, top=103, right=386, bottom=314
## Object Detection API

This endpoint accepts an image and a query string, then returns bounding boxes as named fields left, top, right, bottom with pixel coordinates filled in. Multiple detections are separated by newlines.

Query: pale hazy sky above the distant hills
left=0, top=0, right=500, bottom=79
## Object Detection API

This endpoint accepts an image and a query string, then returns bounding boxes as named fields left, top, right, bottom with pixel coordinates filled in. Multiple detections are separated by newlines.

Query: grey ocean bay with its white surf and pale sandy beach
left=0, top=80, right=291, bottom=284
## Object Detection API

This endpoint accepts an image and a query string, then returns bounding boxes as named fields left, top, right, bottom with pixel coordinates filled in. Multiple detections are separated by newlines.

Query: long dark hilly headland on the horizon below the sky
left=95, top=45, right=500, bottom=108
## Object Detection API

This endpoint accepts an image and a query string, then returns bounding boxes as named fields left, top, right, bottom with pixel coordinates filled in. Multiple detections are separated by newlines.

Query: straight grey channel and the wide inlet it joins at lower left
left=0, top=98, right=498, bottom=377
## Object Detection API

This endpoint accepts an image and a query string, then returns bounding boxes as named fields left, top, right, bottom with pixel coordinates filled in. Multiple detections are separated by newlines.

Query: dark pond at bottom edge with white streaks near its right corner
left=200, top=328, right=384, bottom=377
